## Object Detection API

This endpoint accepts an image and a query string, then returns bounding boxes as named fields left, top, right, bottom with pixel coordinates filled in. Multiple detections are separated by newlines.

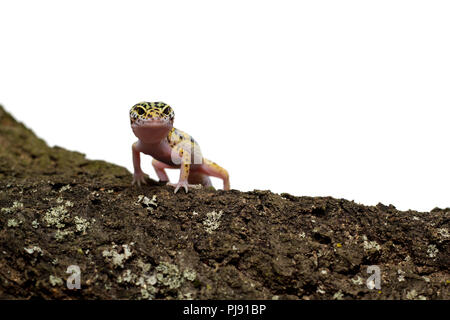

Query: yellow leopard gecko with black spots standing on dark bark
left=130, top=102, right=230, bottom=193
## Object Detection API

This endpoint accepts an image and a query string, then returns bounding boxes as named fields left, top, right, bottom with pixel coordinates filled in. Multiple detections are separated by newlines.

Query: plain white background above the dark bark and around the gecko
left=0, top=0, right=450, bottom=210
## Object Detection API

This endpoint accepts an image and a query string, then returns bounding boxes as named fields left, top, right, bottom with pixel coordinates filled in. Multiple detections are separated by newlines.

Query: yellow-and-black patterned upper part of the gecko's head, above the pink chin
left=130, top=102, right=175, bottom=123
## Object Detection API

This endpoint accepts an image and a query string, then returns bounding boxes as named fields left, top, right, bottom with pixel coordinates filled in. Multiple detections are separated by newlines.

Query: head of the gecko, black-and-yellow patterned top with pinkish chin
left=130, top=102, right=175, bottom=143
